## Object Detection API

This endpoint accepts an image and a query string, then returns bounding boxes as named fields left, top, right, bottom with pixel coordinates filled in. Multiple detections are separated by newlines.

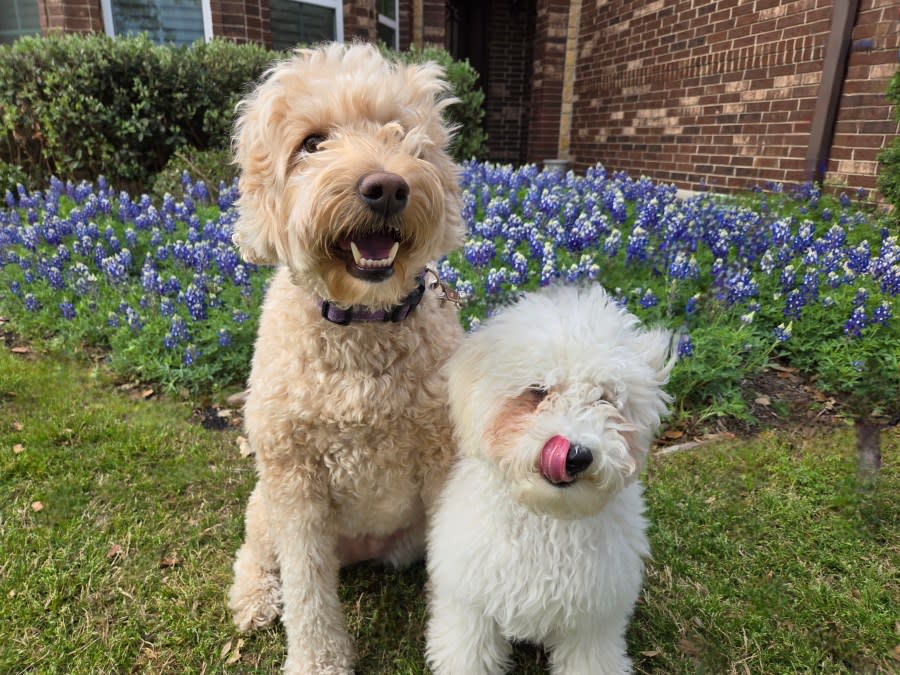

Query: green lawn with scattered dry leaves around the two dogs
left=0, top=350, right=900, bottom=674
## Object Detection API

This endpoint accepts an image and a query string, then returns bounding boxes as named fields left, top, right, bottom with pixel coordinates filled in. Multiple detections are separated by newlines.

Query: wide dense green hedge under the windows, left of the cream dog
left=0, top=34, right=279, bottom=191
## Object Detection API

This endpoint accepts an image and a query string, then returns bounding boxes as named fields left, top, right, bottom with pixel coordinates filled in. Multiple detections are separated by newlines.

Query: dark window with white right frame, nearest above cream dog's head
left=269, top=0, right=344, bottom=49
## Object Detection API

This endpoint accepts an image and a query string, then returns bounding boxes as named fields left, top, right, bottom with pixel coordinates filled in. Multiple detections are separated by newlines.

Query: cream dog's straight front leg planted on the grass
left=275, top=494, right=355, bottom=675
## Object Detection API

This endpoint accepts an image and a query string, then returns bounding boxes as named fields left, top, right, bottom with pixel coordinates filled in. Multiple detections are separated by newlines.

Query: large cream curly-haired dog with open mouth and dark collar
left=229, top=44, right=463, bottom=674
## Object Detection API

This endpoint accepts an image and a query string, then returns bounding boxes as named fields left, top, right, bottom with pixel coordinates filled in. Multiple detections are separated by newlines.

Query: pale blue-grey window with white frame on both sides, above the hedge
left=101, top=0, right=212, bottom=45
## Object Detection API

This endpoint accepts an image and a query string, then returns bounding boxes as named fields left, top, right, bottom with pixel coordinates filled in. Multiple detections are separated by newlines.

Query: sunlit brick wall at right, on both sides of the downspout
left=571, top=0, right=898, bottom=195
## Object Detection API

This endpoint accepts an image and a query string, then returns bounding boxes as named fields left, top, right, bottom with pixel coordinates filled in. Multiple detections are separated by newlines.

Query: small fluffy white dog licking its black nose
left=427, top=286, right=673, bottom=675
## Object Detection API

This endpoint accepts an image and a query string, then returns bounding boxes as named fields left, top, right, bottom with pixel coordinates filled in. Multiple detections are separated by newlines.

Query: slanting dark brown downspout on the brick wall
left=806, top=0, right=859, bottom=181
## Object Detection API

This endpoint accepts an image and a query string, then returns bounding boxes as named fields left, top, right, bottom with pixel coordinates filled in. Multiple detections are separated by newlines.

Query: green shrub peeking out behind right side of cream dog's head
left=381, top=45, right=488, bottom=162
